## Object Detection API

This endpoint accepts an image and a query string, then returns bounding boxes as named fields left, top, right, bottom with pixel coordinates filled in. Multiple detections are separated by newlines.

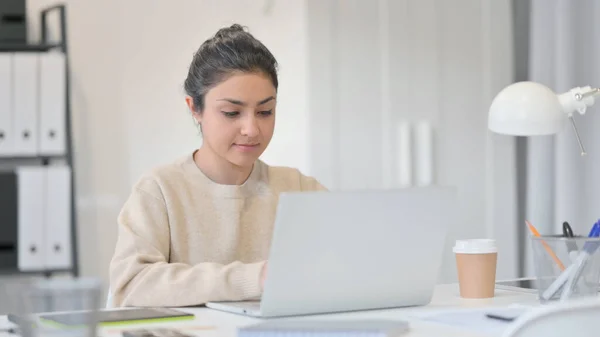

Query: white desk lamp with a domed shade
left=488, top=82, right=600, bottom=156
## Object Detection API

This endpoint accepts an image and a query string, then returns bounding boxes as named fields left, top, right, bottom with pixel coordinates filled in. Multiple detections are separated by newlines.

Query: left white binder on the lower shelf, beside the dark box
left=16, top=167, right=46, bottom=271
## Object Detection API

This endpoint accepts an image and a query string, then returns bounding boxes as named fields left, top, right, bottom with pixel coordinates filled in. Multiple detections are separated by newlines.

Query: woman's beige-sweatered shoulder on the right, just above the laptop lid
left=263, top=163, right=327, bottom=191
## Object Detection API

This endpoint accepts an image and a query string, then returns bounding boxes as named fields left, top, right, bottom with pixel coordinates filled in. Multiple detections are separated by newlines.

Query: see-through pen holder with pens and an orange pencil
left=531, top=236, right=600, bottom=303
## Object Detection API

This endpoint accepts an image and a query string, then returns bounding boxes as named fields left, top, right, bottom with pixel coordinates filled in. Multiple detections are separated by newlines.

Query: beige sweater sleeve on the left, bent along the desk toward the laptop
left=109, top=182, right=265, bottom=307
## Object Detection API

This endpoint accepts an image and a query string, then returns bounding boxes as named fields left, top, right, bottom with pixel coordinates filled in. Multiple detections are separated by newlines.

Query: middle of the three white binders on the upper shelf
left=12, top=52, right=38, bottom=156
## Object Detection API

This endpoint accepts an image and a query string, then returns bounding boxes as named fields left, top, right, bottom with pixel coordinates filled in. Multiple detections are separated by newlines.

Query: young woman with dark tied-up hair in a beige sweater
left=110, top=25, right=325, bottom=307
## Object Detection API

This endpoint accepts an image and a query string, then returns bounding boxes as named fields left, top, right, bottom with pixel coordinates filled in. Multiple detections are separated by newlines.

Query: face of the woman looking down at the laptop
left=188, top=73, right=277, bottom=167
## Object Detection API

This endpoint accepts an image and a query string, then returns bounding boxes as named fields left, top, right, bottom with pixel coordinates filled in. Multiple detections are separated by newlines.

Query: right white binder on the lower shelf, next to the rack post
left=44, top=166, right=72, bottom=269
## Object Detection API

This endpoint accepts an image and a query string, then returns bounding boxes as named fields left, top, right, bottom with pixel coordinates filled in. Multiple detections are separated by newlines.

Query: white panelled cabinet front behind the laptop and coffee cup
left=308, top=0, right=518, bottom=281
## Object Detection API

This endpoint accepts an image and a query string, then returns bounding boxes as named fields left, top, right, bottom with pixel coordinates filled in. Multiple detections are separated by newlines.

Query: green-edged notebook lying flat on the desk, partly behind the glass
left=39, top=308, right=194, bottom=326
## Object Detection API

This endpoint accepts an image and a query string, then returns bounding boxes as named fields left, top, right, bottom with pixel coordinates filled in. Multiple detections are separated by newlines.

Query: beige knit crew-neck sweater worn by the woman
left=110, top=154, right=325, bottom=306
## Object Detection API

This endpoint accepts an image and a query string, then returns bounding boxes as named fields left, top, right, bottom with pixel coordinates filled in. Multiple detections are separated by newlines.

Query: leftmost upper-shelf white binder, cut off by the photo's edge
left=0, top=53, right=14, bottom=157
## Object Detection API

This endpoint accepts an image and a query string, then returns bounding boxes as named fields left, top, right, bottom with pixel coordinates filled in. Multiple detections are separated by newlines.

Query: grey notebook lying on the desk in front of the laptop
left=238, top=319, right=408, bottom=337
